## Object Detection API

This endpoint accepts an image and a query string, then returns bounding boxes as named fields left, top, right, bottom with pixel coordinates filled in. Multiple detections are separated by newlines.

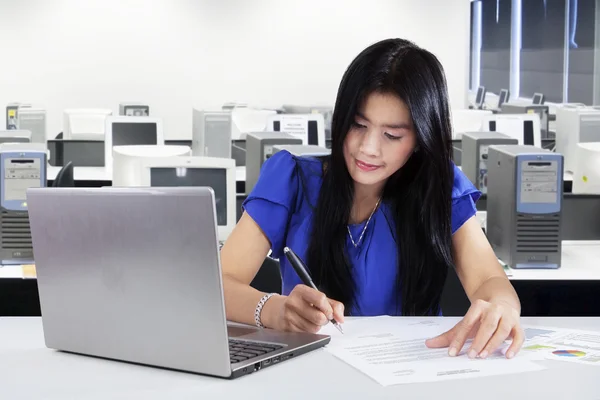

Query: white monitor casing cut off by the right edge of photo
left=572, top=142, right=600, bottom=194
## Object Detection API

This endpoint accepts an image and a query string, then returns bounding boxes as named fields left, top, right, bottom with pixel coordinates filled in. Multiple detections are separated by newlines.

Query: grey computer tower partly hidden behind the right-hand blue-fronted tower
left=461, top=132, right=519, bottom=194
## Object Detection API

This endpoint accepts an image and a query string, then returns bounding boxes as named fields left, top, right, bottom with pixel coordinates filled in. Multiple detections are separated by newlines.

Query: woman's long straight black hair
left=307, top=39, right=454, bottom=315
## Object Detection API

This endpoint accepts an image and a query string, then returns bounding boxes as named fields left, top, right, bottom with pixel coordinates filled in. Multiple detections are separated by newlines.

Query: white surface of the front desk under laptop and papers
left=0, top=318, right=600, bottom=400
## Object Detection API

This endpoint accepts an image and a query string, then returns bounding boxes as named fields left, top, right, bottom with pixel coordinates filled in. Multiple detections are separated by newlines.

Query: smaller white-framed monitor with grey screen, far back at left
left=104, top=116, right=165, bottom=170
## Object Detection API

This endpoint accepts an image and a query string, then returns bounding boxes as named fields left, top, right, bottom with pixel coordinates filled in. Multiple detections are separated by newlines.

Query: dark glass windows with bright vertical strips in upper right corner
left=469, top=0, right=600, bottom=105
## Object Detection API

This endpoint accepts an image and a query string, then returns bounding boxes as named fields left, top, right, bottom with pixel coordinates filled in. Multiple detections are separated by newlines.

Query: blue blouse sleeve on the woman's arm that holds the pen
left=242, top=151, right=299, bottom=258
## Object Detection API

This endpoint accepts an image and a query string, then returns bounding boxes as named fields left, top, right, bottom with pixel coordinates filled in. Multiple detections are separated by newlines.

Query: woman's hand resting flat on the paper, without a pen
left=425, top=300, right=525, bottom=358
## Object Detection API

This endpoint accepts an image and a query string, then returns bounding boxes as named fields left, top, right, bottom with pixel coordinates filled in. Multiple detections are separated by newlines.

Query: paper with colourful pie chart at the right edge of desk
left=521, top=327, right=600, bottom=367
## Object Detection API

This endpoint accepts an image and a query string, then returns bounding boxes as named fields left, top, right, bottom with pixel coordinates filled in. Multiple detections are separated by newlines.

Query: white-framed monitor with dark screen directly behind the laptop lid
left=140, top=157, right=236, bottom=241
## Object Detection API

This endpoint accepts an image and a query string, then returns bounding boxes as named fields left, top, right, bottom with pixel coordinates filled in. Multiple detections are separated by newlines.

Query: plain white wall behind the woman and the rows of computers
left=0, top=0, right=469, bottom=139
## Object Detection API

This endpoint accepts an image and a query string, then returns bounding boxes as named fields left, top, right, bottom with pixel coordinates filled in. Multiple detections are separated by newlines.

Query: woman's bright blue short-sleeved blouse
left=242, top=151, right=481, bottom=316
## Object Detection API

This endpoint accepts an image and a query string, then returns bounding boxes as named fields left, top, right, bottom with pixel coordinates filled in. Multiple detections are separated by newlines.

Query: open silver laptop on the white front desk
left=27, top=187, right=330, bottom=378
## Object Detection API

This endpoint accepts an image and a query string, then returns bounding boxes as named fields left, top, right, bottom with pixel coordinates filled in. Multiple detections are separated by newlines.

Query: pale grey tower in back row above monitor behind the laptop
left=192, top=109, right=232, bottom=158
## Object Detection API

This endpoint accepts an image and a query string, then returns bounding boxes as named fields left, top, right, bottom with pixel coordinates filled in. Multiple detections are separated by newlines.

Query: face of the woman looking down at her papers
left=344, top=93, right=417, bottom=191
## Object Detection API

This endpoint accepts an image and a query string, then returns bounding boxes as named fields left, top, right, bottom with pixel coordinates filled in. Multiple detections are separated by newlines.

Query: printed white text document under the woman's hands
left=321, top=317, right=545, bottom=386
